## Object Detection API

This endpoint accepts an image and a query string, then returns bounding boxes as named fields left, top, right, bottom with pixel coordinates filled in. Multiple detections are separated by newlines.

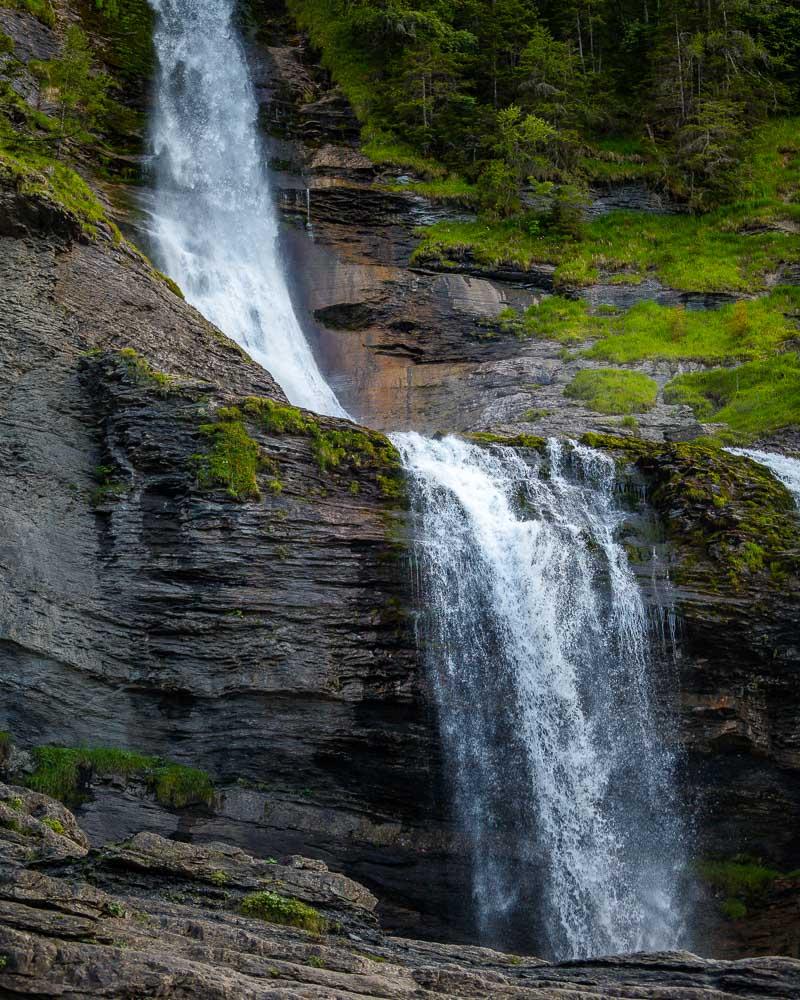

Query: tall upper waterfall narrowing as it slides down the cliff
left=145, top=0, right=345, bottom=416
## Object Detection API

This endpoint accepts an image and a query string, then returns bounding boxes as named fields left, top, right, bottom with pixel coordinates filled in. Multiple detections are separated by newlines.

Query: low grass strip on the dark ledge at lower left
left=26, top=746, right=214, bottom=808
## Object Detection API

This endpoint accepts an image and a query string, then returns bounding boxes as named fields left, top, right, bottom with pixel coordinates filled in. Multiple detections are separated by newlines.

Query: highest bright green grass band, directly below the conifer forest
left=413, top=118, right=800, bottom=292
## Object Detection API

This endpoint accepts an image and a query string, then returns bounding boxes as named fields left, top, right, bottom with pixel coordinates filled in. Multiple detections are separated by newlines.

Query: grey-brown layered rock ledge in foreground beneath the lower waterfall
left=0, top=808, right=800, bottom=1000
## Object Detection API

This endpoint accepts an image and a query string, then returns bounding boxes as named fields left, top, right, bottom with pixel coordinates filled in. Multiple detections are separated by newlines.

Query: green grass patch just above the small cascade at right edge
left=664, top=352, right=800, bottom=444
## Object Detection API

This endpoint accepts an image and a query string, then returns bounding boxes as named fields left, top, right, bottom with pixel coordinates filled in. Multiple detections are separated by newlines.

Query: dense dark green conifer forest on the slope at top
left=289, top=0, right=800, bottom=208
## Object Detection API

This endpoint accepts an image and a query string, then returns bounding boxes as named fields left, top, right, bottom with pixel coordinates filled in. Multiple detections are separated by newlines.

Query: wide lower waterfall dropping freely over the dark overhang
left=394, top=434, right=684, bottom=958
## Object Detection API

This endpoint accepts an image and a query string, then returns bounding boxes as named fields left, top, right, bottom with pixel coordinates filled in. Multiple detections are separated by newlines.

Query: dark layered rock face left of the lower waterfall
left=0, top=189, right=462, bottom=940
